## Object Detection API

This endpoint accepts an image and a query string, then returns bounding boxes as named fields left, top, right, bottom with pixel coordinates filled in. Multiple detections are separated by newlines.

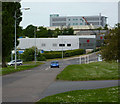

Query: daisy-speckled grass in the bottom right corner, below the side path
left=36, top=87, right=119, bottom=104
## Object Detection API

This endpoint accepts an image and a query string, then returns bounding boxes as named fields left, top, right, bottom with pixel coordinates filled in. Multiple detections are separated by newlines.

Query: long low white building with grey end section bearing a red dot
left=17, top=35, right=96, bottom=51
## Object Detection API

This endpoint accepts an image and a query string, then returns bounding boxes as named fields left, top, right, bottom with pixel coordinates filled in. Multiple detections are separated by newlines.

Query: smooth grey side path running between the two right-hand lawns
left=40, top=80, right=118, bottom=99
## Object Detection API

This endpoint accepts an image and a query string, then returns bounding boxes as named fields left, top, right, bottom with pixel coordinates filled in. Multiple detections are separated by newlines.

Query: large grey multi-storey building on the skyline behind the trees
left=50, top=13, right=107, bottom=27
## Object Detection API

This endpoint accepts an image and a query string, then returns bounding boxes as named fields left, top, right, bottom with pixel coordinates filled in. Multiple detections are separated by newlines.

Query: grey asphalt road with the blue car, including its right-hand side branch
left=2, top=54, right=118, bottom=104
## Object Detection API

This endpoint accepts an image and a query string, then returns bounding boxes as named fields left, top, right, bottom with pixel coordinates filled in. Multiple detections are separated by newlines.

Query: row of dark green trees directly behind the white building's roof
left=19, top=25, right=74, bottom=38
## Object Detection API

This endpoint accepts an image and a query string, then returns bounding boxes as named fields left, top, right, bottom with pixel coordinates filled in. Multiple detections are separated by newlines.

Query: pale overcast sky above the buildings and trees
left=20, top=0, right=118, bottom=28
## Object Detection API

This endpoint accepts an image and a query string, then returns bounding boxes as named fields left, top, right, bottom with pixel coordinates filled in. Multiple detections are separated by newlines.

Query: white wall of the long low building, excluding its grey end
left=17, top=35, right=95, bottom=51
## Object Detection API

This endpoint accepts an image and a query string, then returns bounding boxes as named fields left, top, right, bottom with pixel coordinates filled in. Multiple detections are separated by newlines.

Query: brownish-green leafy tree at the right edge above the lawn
left=101, top=24, right=120, bottom=61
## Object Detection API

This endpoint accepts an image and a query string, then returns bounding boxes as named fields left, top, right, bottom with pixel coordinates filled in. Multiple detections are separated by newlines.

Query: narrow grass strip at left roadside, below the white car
left=0, top=62, right=43, bottom=75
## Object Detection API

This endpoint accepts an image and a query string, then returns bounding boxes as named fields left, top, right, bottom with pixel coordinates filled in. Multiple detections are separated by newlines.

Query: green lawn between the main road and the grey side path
left=56, top=62, right=118, bottom=81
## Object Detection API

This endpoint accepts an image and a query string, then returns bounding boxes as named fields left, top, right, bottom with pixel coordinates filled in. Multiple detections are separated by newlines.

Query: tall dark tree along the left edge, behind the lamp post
left=2, top=2, right=22, bottom=67
